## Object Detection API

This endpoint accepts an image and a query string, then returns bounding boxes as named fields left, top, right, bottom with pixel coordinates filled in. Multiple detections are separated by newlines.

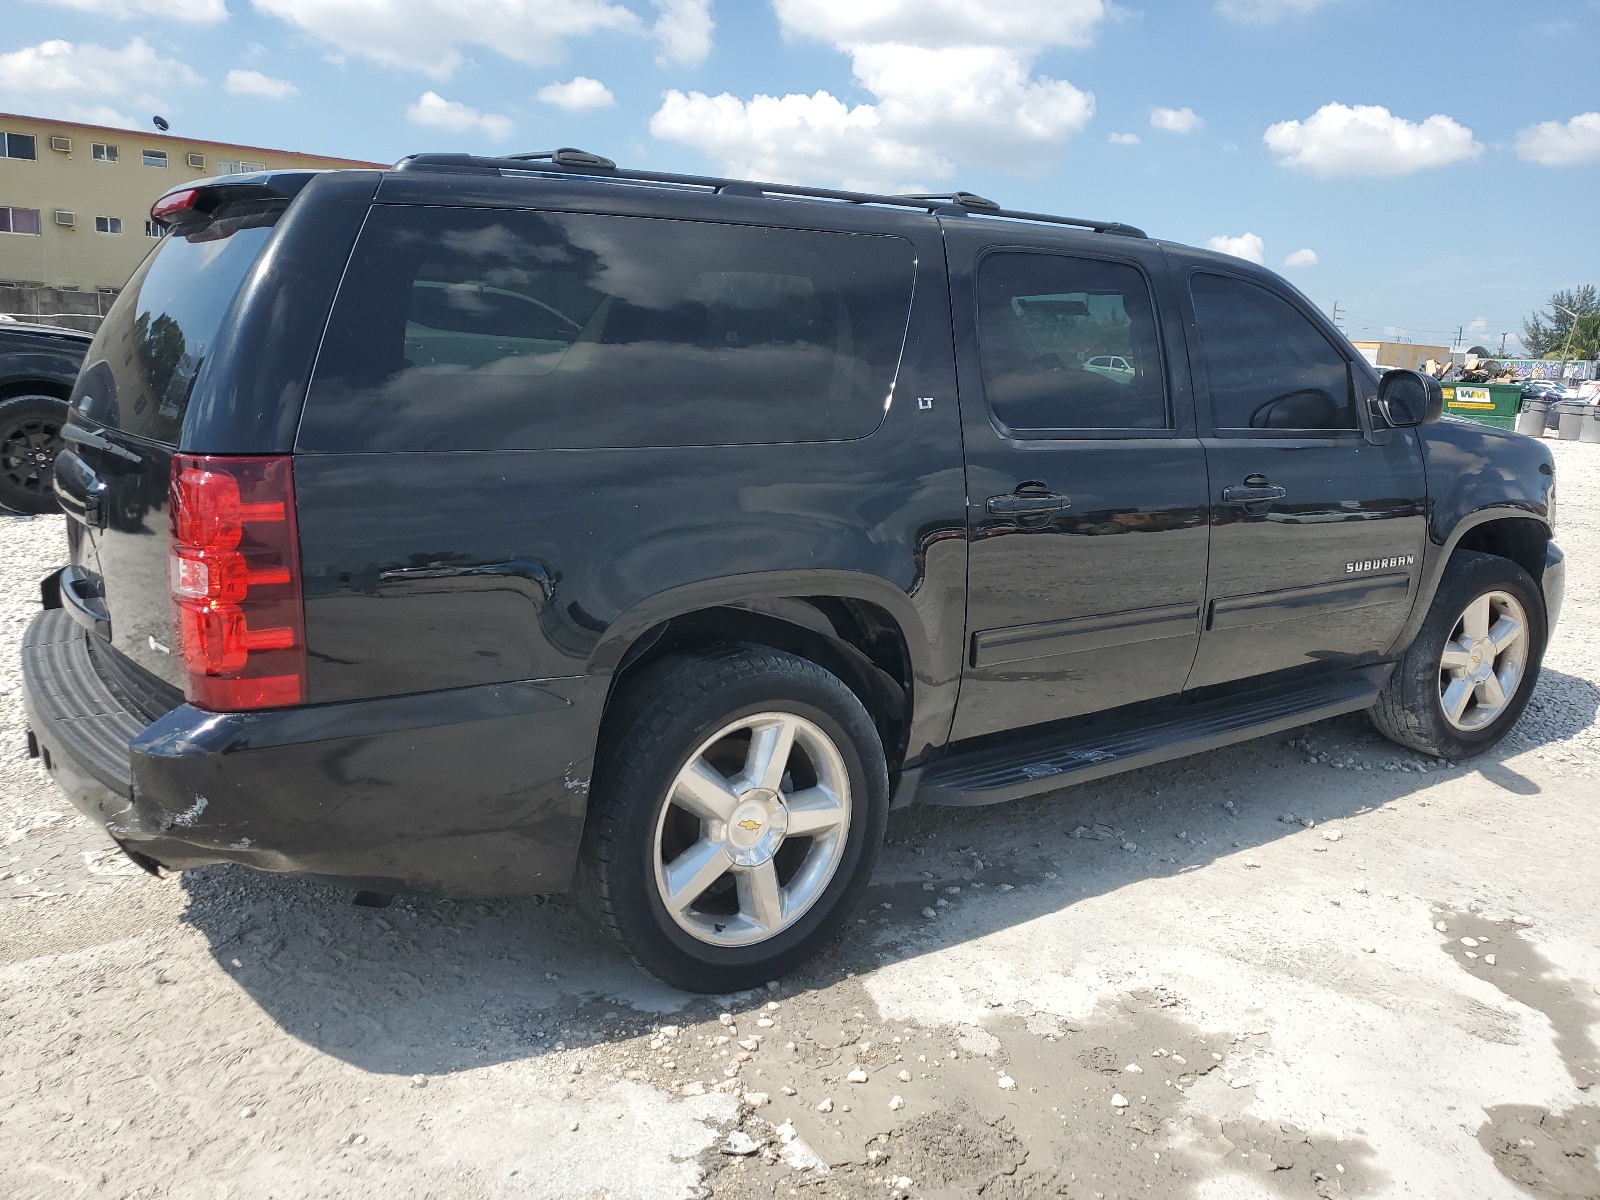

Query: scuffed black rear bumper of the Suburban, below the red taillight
left=22, top=610, right=606, bottom=894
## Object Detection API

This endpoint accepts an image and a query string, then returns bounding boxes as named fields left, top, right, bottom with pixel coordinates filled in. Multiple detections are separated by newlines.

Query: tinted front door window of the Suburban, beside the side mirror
left=1190, top=275, right=1358, bottom=429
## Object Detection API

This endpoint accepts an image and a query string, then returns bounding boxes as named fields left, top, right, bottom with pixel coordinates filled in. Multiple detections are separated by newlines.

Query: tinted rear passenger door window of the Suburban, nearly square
left=978, top=253, right=1168, bottom=429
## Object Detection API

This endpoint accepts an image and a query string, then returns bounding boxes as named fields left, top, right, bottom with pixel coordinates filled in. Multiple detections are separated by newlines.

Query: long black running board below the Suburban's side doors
left=917, top=662, right=1394, bottom=806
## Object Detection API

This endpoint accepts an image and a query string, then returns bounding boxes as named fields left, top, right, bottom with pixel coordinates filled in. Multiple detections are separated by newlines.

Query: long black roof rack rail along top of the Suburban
left=394, top=146, right=1146, bottom=237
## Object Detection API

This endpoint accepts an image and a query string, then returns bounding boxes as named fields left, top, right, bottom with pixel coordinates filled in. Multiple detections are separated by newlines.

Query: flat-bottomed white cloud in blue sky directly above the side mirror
left=1262, top=104, right=1483, bottom=178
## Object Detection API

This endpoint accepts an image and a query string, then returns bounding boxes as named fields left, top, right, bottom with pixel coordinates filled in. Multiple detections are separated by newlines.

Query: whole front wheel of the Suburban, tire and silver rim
left=1371, top=550, right=1547, bottom=760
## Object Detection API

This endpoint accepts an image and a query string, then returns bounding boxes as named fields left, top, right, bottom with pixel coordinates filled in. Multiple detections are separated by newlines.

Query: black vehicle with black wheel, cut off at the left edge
left=0, top=320, right=90, bottom=512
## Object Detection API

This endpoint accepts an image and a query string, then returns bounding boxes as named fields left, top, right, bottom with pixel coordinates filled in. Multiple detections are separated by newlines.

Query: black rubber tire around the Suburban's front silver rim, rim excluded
left=1368, top=550, right=1549, bottom=762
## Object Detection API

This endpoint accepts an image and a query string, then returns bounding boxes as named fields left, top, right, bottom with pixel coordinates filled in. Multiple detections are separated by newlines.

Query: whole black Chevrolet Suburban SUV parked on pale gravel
left=22, top=150, right=1563, bottom=992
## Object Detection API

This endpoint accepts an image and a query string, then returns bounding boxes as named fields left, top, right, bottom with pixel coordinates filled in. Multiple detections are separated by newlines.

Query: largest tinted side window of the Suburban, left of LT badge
left=299, top=206, right=915, bottom=451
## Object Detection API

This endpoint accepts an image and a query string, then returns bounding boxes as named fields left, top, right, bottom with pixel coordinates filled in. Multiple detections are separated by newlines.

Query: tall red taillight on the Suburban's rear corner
left=168, top=454, right=306, bottom=712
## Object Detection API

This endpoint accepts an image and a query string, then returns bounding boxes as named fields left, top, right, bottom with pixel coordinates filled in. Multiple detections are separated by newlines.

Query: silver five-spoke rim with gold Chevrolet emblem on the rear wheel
left=654, top=712, right=851, bottom=946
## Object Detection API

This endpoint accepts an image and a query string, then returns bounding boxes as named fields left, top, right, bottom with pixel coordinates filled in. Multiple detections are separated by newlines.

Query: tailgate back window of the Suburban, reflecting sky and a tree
left=74, top=211, right=277, bottom=445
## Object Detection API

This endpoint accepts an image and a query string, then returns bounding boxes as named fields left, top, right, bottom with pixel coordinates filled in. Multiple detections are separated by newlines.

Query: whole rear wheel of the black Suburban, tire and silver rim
left=578, top=646, right=888, bottom=992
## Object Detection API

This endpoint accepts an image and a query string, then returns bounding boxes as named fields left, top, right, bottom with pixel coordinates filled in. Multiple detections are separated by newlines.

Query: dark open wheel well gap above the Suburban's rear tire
left=606, top=597, right=914, bottom=771
